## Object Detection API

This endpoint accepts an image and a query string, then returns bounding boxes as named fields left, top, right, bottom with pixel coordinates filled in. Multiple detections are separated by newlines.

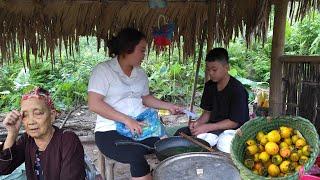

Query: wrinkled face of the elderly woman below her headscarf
left=21, top=98, right=55, bottom=139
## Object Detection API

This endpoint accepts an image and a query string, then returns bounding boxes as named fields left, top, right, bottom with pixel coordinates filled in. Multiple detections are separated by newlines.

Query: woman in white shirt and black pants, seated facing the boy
left=88, top=28, right=181, bottom=180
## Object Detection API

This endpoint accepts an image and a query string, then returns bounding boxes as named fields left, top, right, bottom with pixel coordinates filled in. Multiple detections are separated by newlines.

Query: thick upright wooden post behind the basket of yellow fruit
left=269, top=0, right=288, bottom=116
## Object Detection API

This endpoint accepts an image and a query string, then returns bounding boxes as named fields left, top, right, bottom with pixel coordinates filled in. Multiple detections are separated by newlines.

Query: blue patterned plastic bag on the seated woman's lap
left=116, top=108, right=167, bottom=141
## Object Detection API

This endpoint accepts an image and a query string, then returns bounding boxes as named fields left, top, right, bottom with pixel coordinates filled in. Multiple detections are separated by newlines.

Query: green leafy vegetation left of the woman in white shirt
left=0, top=38, right=105, bottom=112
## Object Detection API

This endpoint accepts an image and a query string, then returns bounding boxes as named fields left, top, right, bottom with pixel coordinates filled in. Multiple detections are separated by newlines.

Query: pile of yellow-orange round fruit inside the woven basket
left=243, top=126, right=312, bottom=177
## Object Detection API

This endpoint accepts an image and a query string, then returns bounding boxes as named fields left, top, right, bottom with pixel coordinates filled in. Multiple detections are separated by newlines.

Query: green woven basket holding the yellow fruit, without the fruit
left=231, top=116, right=319, bottom=179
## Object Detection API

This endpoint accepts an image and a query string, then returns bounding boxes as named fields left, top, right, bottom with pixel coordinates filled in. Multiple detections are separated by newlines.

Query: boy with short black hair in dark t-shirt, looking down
left=175, top=48, right=249, bottom=136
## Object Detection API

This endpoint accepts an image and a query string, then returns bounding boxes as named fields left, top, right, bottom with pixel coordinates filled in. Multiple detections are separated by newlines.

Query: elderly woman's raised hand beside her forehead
left=3, top=110, right=22, bottom=134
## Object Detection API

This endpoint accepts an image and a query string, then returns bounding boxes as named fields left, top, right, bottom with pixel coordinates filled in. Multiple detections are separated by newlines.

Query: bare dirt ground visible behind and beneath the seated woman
left=0, top=106, right=188, bottom=180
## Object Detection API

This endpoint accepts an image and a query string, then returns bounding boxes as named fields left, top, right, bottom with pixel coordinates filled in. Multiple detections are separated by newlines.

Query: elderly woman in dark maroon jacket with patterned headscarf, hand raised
left=0, top=88, right=85, bottom=180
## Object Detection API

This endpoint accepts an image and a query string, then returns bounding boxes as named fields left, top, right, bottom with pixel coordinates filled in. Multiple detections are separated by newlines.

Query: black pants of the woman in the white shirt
left=95, top=131, right=160, bottom=177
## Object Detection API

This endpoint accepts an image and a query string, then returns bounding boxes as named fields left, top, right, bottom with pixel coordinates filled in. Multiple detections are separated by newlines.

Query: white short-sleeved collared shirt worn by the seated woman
left=88, top=57, right=149, bottom=132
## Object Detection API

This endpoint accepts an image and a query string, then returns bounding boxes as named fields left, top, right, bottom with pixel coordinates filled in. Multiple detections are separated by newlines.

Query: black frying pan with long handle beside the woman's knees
left=115, top=136, right=210, bottom=161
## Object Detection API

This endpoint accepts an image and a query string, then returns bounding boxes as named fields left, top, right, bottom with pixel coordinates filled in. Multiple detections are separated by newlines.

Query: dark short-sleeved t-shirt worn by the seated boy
left=200, top=76, right=249, bottom=128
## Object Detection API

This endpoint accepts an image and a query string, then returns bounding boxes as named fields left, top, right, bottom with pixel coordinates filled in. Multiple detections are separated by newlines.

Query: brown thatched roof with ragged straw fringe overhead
left=0, top=0, right=320, bottom=67
